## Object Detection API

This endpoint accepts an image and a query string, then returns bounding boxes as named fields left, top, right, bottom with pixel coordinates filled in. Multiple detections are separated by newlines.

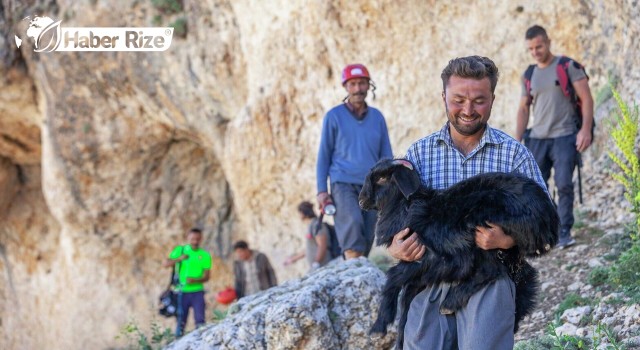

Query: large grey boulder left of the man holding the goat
left=166, top=258, right=396, bottom=350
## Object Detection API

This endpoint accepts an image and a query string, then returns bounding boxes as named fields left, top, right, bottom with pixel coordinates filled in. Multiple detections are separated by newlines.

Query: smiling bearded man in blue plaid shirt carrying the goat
left=388, top=56, right=549, bottom=349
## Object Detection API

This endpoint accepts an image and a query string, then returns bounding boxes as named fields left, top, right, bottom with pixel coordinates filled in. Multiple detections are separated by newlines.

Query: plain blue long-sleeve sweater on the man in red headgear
left=316, top=104, right=393, bottom=193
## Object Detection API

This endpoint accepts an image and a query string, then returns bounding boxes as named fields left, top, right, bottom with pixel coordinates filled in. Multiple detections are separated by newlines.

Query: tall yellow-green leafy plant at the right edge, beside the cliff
left=609, top=83, right=640, bottom=239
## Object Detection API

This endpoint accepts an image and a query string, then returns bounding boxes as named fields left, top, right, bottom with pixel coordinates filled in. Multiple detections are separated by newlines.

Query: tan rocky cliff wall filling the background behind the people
left=0, top=0, right=640, bottom=349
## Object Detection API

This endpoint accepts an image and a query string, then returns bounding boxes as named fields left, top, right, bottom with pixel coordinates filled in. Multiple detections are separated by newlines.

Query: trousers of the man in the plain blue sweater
left=331, top=182, right=376, bottom=256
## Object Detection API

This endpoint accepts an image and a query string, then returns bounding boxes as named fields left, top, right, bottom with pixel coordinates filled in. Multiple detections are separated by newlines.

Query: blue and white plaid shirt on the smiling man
left=406, top=122, right=548, bottom=193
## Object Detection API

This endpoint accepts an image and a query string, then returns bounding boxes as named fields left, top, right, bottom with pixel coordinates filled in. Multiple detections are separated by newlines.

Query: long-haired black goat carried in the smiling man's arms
left=359, top=159, right=559, bottom=349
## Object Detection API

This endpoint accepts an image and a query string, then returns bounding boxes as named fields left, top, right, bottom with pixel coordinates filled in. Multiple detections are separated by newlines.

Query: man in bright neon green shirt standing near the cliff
left=164, top=228, right=211, bottom=337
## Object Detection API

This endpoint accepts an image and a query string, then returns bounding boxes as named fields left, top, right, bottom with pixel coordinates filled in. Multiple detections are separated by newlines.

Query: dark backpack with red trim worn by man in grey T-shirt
left=524, top=56, right=596, bottom=140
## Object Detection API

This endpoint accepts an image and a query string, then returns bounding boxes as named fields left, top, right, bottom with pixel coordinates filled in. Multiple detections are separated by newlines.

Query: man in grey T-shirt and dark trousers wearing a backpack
left=515, top=25, right=593, bottom=249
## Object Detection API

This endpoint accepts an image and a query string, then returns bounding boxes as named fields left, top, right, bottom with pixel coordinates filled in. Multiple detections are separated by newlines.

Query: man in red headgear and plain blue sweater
left=316, top=64, right=393, bottom=259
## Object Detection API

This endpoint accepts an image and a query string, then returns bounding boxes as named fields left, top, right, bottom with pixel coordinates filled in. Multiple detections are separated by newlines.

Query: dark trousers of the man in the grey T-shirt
left=525, top=134, right=578, bottom=238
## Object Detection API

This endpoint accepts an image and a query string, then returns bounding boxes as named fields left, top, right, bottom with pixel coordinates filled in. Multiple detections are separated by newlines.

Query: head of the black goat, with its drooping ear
left=358, top=159, right=420, bottom=210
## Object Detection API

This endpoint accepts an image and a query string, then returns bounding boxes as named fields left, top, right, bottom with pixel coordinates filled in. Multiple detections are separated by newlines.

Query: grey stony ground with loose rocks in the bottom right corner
left=516, top=217, right=640, bottom=349
